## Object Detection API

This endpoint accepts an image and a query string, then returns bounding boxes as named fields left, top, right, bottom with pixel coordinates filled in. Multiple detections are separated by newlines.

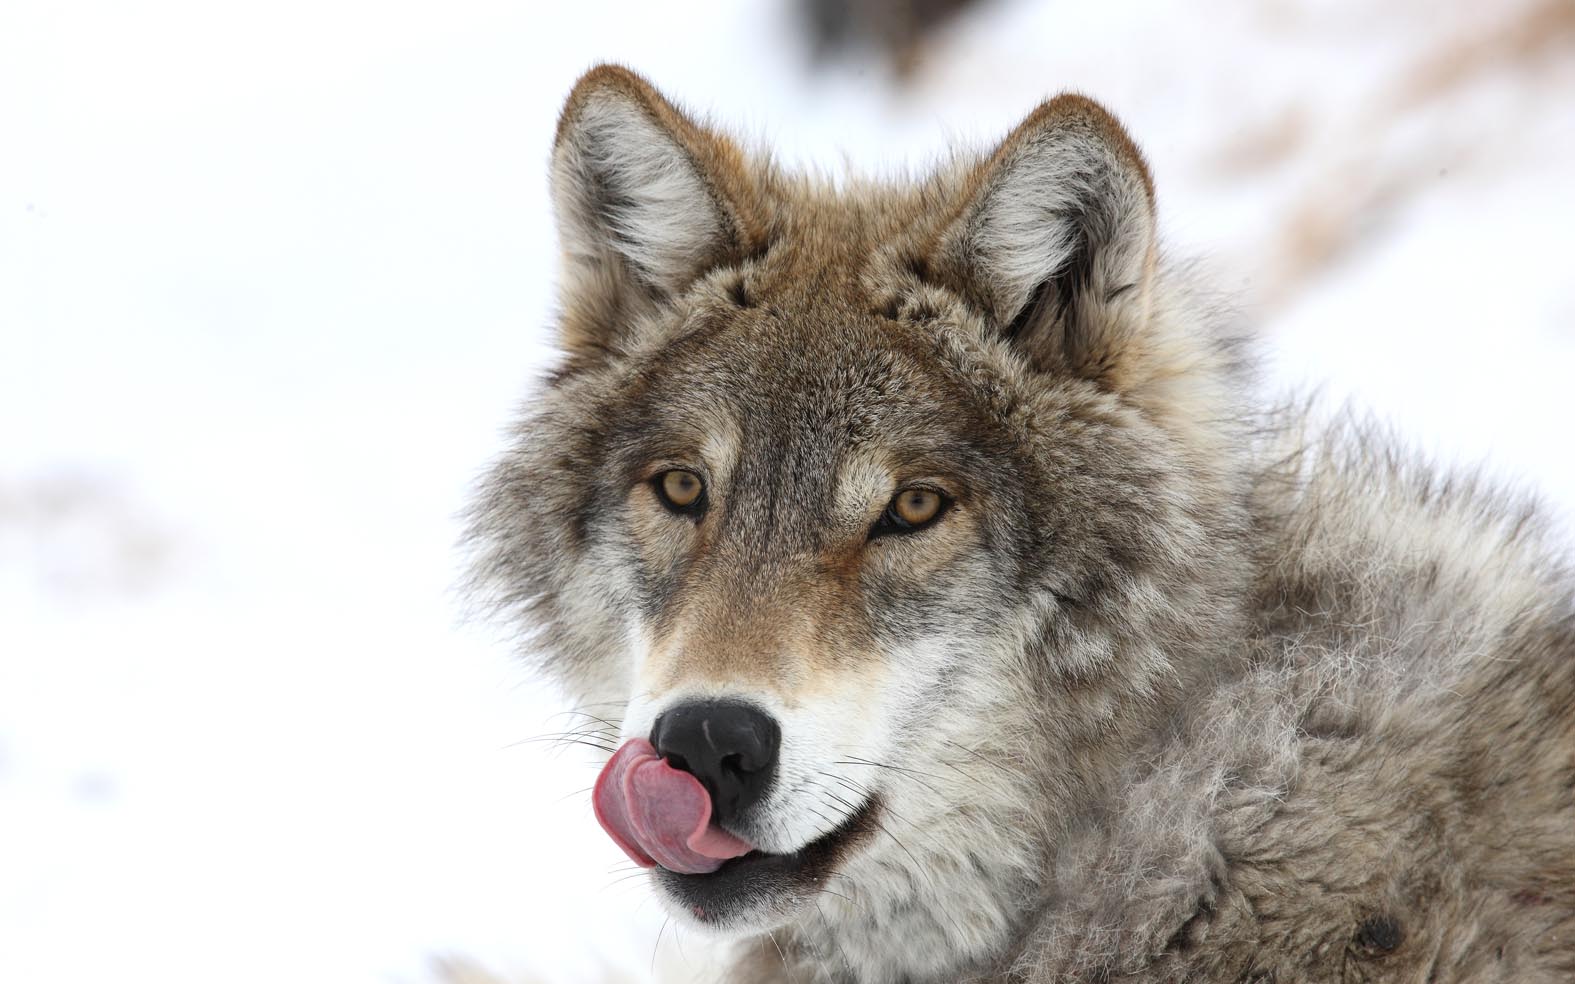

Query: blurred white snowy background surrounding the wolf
left=0, top=0, right=1575, bottom=984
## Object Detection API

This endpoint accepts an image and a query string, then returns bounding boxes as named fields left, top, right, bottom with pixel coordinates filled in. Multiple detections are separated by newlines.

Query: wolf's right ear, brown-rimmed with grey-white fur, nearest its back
left=929, top=94, right=1154, bottom=389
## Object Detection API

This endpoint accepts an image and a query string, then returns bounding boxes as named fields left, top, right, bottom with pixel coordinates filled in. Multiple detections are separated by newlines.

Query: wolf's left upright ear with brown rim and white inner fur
left=551, top=65, right=754, bottom=356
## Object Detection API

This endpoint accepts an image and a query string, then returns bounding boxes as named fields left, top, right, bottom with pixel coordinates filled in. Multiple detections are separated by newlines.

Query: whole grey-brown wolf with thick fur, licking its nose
left=469, top=66, right=1575, bottom=984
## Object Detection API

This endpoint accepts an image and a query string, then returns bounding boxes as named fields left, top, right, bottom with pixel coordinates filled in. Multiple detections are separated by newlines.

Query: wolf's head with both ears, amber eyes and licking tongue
left=473, top=66, right=1246, bottom=979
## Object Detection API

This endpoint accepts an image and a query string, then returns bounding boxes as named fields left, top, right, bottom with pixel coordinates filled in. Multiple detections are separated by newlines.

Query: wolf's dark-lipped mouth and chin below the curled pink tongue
left=654, top=795, right=880, bottom=926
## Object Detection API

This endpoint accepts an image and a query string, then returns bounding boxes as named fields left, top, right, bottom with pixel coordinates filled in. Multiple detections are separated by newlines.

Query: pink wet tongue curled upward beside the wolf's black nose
left=591, top=738, right=753, bottom=875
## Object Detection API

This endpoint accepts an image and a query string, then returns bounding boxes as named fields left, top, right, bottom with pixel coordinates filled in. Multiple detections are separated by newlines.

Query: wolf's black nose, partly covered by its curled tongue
left=650, top=701, right=781, bottom=825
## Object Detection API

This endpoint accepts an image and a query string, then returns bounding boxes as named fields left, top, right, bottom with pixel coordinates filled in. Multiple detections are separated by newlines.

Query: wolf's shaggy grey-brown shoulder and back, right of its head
left=1000, top=425, right=1575, bottom=984
